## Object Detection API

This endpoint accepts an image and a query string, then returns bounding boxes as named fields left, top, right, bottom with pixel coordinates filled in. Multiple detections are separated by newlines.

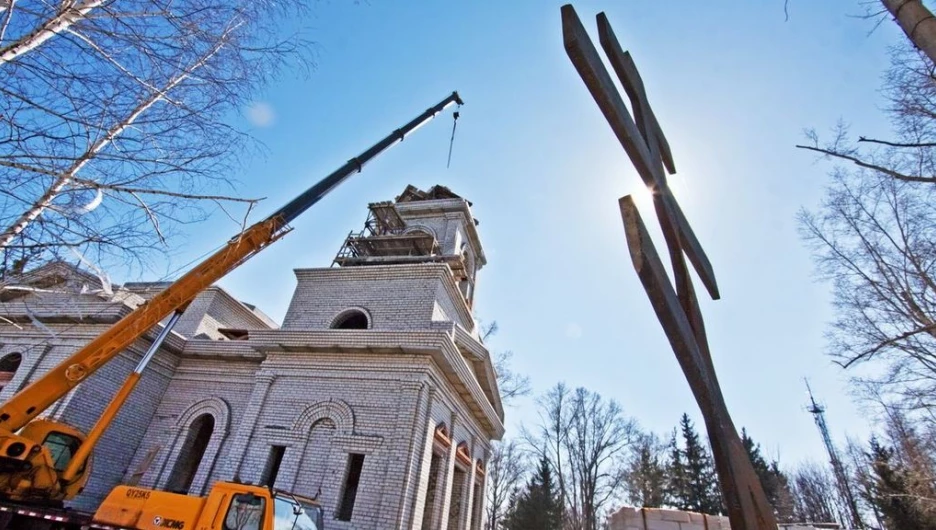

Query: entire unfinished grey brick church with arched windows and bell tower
left=0, top=186, right=504, bottom=530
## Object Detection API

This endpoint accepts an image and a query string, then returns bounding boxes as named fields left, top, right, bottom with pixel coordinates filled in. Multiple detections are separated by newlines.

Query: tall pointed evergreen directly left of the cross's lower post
left=679, top=413, right=723, bottom=514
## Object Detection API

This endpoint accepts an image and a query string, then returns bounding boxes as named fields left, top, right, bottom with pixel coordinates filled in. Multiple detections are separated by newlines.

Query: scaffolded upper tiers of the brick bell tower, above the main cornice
left=283, top=186, right=487, bottom=339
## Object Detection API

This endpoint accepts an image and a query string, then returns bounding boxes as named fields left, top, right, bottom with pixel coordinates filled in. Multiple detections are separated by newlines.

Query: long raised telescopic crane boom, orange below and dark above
left=0, top=92, right=462, bottom=434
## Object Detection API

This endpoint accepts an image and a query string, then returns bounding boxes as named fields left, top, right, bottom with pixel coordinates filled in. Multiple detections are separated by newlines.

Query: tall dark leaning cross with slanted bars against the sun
left=561, top=5, right=777, bottom=530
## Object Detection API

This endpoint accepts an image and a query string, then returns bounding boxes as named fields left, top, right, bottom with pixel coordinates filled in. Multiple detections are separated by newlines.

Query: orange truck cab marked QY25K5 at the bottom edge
left=88, top=482, right=324, bottom=530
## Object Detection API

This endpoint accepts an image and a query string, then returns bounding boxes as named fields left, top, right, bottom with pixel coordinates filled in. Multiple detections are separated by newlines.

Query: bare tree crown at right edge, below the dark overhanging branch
left=800, top=156, right=936, bottom=407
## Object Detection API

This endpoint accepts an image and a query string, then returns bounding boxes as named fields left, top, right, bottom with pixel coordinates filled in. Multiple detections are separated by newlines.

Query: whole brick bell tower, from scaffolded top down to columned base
left=161, top=186, right=504, bottom=530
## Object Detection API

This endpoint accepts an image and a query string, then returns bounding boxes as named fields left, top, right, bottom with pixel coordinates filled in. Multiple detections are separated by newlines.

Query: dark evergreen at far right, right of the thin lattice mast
left=868, top=438, right=936, bottom=530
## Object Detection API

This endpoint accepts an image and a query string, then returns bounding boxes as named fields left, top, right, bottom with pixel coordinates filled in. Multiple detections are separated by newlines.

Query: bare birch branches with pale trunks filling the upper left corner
left=0, top=0, right=308, bottom=273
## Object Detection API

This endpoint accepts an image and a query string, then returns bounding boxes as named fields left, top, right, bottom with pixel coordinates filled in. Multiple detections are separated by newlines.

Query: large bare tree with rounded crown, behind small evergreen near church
left=524, top=383, right=638, bottom=530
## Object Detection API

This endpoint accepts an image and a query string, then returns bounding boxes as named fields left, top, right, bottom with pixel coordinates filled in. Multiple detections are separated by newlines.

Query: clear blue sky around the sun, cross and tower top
left=157, top=0, right=903, bottom=465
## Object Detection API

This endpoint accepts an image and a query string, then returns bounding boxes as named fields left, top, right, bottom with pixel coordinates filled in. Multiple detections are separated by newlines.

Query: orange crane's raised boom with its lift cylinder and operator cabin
left=0, top=92, right=463, bottom=528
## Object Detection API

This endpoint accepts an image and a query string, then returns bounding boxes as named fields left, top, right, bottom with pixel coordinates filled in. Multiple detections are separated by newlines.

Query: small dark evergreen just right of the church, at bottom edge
left=504, top=458, right=562, bottom=530
